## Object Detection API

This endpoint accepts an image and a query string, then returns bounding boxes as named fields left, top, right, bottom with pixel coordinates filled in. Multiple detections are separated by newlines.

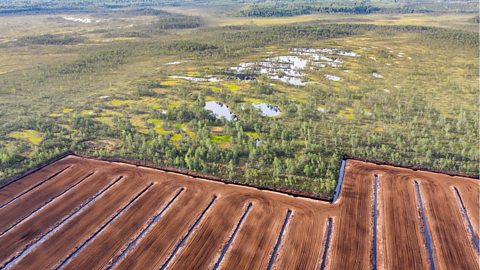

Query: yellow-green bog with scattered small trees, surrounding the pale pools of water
left=0, top=4, right=479, bottom=196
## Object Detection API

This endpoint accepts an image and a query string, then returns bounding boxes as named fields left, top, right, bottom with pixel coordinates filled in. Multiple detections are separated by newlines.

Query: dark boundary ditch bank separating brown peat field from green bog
left=0, top=151, right=480, bottom=203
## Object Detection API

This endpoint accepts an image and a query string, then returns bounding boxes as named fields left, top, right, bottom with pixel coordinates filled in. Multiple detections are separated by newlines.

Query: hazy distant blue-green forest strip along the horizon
left=0, top=0, right=478, bottom=17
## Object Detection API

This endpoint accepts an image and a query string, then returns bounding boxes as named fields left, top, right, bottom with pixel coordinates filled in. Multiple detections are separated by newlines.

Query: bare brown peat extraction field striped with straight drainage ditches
left=0, top=155, right=480, bottom=269
